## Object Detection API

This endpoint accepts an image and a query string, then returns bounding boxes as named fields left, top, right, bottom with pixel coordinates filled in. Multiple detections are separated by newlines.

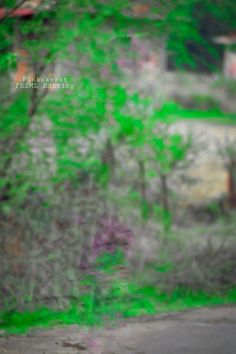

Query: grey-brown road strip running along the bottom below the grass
left=0, top=306, right=236, bottom=354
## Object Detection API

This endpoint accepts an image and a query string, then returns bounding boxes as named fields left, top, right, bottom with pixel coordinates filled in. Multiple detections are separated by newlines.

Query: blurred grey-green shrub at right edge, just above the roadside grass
left=145, top=216, right=236, bottom=293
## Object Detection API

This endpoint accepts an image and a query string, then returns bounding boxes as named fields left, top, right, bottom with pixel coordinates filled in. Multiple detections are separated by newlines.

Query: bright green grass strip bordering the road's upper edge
left=0, top=285, right=236, bottom=334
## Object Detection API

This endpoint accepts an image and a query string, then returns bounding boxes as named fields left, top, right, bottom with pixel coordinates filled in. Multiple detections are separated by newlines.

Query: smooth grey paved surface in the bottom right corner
left=132, top=323, right=236, bottom=354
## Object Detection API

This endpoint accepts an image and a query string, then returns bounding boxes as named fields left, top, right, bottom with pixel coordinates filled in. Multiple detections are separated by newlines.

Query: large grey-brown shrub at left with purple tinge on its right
left=0, top=187, right=136, bottom=308
